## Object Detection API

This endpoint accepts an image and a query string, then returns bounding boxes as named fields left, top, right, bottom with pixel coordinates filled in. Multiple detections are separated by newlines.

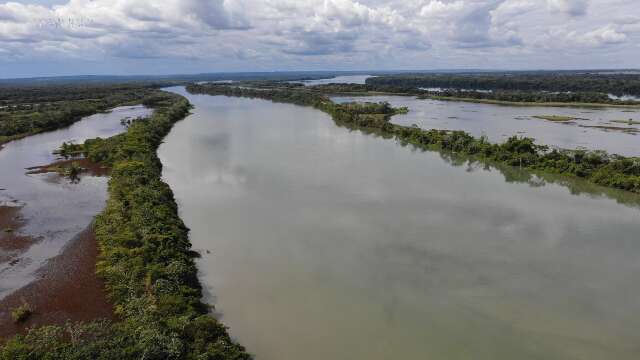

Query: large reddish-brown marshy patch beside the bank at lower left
left=0, top=224, right=115, bottom=343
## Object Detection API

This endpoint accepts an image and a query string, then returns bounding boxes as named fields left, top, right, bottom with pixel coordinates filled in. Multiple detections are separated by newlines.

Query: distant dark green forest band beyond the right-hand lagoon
left=366, top=72, right=640, bottom=96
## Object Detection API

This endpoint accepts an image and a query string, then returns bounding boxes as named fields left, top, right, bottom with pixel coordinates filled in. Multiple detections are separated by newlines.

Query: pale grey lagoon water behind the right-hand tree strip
left=333, top=96, right=640, bottom=156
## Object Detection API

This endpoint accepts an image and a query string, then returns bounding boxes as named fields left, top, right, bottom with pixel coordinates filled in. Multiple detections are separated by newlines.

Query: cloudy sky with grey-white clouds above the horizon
left=0, top=0, right=640, bottom=78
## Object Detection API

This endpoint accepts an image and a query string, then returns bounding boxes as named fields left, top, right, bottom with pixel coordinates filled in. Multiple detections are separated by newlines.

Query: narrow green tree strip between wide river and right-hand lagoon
left=187, top=85, right=640, bottom=193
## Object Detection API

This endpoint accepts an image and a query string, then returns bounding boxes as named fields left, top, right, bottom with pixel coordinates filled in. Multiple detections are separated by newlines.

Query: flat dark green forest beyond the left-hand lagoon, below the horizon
left=0, top=85, right=156, bottom=144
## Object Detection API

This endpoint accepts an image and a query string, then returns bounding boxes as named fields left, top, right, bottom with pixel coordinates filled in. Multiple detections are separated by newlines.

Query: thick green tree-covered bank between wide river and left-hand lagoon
left=0, top=93, right=250, bottom=360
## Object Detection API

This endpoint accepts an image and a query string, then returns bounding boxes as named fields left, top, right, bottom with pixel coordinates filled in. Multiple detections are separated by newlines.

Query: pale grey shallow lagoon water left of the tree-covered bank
left=0, top=106, right=151, bottom=298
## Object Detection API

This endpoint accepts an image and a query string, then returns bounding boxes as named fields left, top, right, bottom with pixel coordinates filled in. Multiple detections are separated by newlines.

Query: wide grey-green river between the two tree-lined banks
left=159, top=88, right=640, bottom=360
